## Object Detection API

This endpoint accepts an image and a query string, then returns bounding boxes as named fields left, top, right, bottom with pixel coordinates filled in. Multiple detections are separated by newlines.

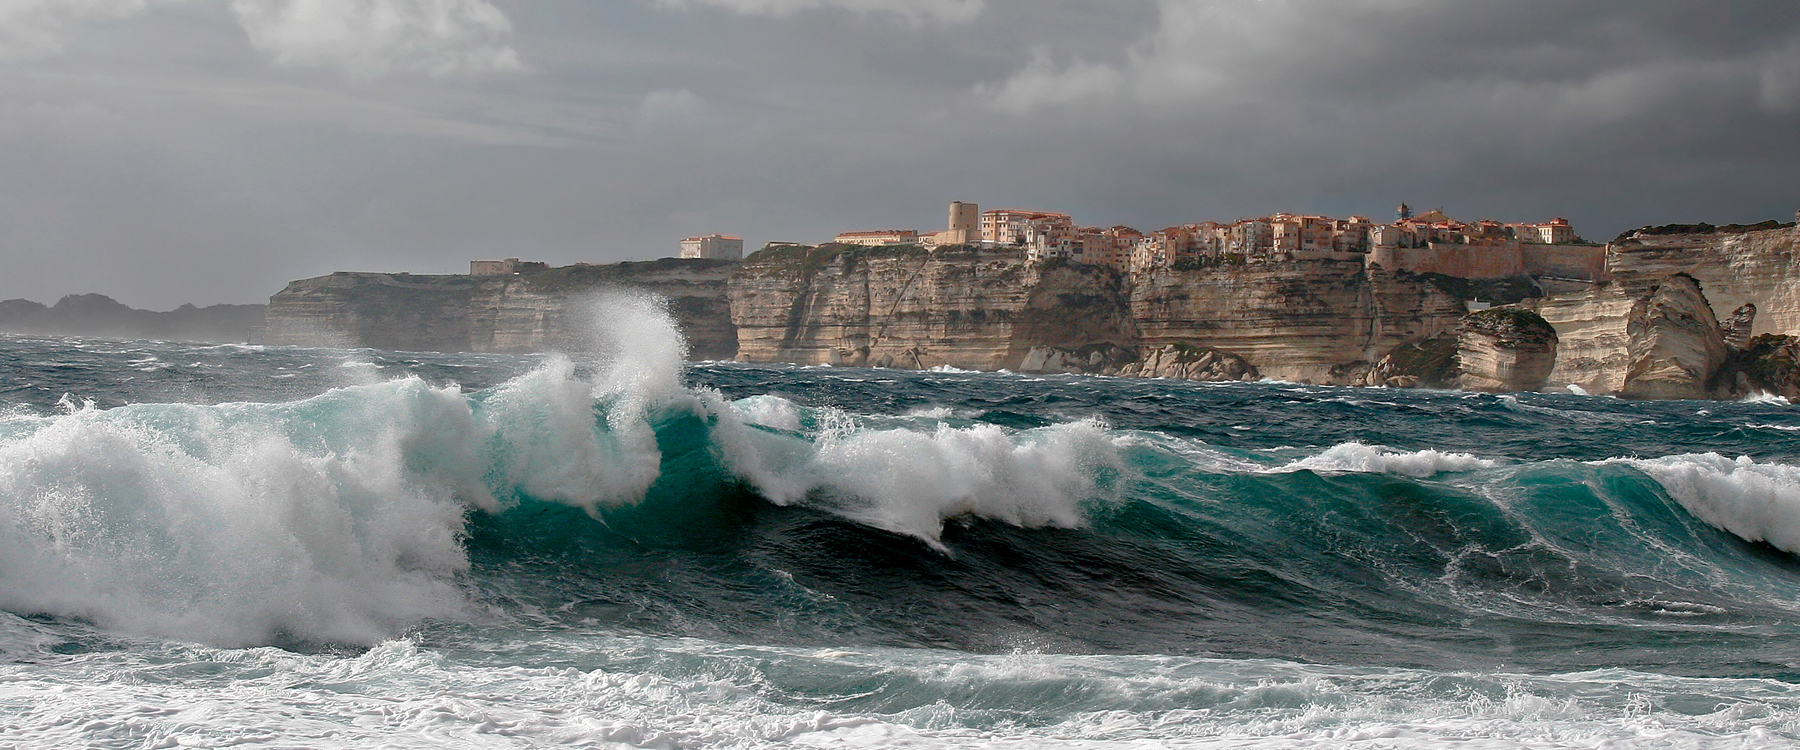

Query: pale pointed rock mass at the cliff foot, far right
left=1618, top=273, right=1728, bottom=399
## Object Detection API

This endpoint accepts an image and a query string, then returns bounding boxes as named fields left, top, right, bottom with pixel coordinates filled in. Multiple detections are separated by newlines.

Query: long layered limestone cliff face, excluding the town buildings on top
left=266, top=227, right=1800, bottom=397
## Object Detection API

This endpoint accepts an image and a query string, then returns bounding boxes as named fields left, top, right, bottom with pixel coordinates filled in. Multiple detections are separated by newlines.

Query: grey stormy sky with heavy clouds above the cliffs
left=0, top=0, right=1800, bottom=309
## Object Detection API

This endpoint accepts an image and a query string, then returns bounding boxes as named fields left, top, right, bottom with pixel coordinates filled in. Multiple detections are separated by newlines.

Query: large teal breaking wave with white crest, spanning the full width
left=0, top=295, right=1800, bottom=662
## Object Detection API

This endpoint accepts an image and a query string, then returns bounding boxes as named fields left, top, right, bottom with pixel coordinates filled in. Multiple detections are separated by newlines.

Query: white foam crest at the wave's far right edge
left=1618, top=453, right=1800, bottom=554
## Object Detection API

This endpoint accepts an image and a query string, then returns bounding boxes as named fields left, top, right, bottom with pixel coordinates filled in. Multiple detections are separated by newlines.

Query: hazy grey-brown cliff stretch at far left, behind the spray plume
left=263, top=259, right=736, bottom=360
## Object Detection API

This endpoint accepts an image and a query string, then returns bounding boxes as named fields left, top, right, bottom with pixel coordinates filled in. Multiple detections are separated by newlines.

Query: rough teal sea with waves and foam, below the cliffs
left=0, top=293, right=1800, bottom=750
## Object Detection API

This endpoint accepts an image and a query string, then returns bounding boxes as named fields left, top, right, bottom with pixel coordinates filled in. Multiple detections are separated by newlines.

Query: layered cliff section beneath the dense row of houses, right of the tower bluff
left=1130, top=261, right=1463, bottom=383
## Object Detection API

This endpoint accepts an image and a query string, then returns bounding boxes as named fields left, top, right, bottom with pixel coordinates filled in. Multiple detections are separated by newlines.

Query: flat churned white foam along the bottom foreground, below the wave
left=0, top=637, right=1800, bottom=750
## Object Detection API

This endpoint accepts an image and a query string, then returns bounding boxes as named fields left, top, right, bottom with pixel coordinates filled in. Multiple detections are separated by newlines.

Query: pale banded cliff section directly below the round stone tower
left=731, top=246, right=1130, bottom=371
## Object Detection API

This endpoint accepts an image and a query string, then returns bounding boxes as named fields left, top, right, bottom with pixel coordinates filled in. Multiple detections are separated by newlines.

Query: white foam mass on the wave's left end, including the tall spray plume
left=0, top=297, right=684, bottom=644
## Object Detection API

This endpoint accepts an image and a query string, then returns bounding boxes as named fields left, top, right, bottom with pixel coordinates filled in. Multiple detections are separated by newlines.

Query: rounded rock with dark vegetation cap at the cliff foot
left=1456, top=308, right=1557, bottom=392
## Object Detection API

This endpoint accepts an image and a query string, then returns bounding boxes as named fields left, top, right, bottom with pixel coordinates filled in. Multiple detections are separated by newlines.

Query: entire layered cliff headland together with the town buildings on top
left=268, top=203, right=1800, bottom=397
